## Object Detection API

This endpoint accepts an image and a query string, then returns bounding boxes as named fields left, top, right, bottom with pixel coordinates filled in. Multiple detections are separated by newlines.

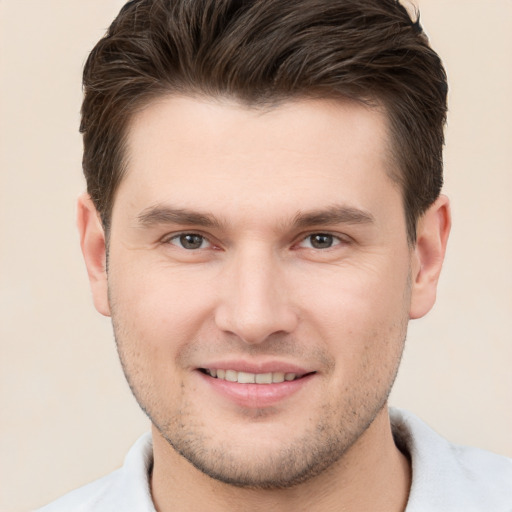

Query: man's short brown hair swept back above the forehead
left=80, top=0, right=447, bottom=242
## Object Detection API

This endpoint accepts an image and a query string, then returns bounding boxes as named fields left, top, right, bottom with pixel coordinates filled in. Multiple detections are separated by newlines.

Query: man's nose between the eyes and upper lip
left=215, top=245, right=298, bottom=344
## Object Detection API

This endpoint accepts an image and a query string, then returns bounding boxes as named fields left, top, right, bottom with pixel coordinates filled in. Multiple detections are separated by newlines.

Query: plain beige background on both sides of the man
left=0, top=0, right=512, bottom=512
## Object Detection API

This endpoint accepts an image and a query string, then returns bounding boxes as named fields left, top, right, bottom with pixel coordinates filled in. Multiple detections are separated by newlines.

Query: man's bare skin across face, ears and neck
left=78, top=97, right=450, bottom=511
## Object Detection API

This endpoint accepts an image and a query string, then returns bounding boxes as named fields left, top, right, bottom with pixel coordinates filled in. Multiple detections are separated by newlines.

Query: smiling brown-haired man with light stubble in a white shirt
left=37, top=0, right=512, bottom=512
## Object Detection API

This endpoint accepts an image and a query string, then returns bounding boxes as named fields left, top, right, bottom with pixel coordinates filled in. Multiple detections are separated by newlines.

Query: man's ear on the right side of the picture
left=409, top=196, right=452, bottom=319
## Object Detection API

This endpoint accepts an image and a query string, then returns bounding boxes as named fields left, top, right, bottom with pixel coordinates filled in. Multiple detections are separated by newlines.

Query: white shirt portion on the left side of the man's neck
left=36, top=434, right=155, bottom=512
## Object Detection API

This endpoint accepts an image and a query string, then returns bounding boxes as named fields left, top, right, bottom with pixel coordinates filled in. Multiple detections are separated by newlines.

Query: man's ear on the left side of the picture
left=77, top=193, right=110, bottom=316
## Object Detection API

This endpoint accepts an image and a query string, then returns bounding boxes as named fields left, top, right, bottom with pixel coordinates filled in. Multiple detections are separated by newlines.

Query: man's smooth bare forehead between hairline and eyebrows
left=114, top=96, right=400, bottom=226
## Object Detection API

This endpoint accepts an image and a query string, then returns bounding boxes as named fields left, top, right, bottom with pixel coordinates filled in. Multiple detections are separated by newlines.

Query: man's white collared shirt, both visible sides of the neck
left=38, top=409, right=512, bottom=512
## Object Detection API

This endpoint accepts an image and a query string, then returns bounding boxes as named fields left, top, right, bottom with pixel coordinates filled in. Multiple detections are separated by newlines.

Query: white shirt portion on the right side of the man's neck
left=390, top=409, right=512, bottom=512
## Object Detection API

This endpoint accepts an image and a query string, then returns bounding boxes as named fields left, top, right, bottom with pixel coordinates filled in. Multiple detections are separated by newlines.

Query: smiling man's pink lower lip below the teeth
left=197, top=371, right=314, bottom=409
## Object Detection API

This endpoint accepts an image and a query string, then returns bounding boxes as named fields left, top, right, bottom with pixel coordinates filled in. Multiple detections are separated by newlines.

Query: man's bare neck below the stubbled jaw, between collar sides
left=151, top=407, right=411, bottom=512
